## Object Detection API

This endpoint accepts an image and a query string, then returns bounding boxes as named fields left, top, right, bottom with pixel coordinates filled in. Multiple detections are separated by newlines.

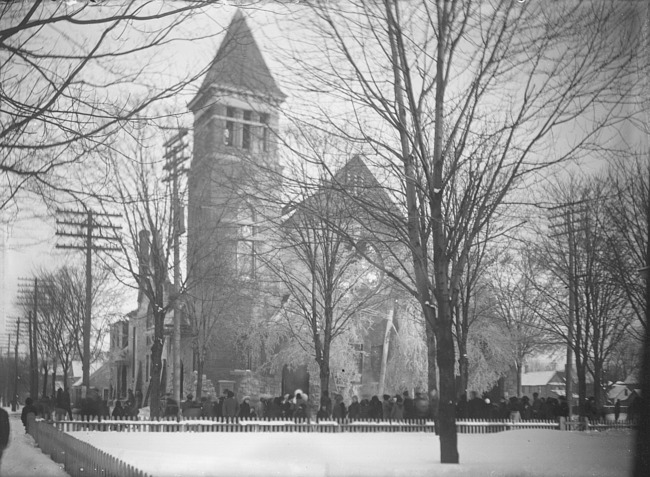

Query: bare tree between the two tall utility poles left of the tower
left=107, top=132, right=178, bottom=416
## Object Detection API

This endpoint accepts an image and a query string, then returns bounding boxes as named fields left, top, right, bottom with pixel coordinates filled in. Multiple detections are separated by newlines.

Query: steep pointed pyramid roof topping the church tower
left=190, top=9, right=286, bottom=109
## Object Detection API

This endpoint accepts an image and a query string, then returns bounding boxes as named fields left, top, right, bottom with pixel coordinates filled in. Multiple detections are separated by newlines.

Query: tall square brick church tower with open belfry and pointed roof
left=187, top=10, right=286, bottom=384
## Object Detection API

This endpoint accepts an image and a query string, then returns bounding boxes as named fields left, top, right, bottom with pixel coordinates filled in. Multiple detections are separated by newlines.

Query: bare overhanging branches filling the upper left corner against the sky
left=0, top=0, right=219, bottom=212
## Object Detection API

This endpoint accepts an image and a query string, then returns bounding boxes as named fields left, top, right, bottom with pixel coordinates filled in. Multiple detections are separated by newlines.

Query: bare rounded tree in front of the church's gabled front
left=256, top=163, right=394, bottom=398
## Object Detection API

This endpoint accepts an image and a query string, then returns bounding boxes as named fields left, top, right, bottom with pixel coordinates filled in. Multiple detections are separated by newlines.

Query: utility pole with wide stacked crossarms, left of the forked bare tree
left=56, top=209, right=121, bottom=395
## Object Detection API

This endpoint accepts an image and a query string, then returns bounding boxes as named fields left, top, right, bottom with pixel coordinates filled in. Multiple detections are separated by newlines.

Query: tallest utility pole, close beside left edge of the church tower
left=163, top=128, right=189, bottom=412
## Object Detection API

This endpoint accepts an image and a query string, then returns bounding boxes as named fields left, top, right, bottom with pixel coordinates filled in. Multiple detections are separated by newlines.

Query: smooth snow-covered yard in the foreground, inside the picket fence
left=70, top=430, right=634, bottom=477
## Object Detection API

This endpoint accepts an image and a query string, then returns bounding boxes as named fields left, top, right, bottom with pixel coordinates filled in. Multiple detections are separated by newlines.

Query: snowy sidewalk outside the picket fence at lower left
left=0, top=410, right=70, bottom=477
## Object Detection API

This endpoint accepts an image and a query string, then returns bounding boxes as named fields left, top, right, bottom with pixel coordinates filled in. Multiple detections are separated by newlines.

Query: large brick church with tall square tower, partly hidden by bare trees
left=112, top=10, right=408, bottom=408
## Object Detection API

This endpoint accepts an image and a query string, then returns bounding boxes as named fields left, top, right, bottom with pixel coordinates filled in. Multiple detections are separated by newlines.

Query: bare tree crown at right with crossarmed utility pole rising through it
left=529, top=178, right=633, bottom=417
